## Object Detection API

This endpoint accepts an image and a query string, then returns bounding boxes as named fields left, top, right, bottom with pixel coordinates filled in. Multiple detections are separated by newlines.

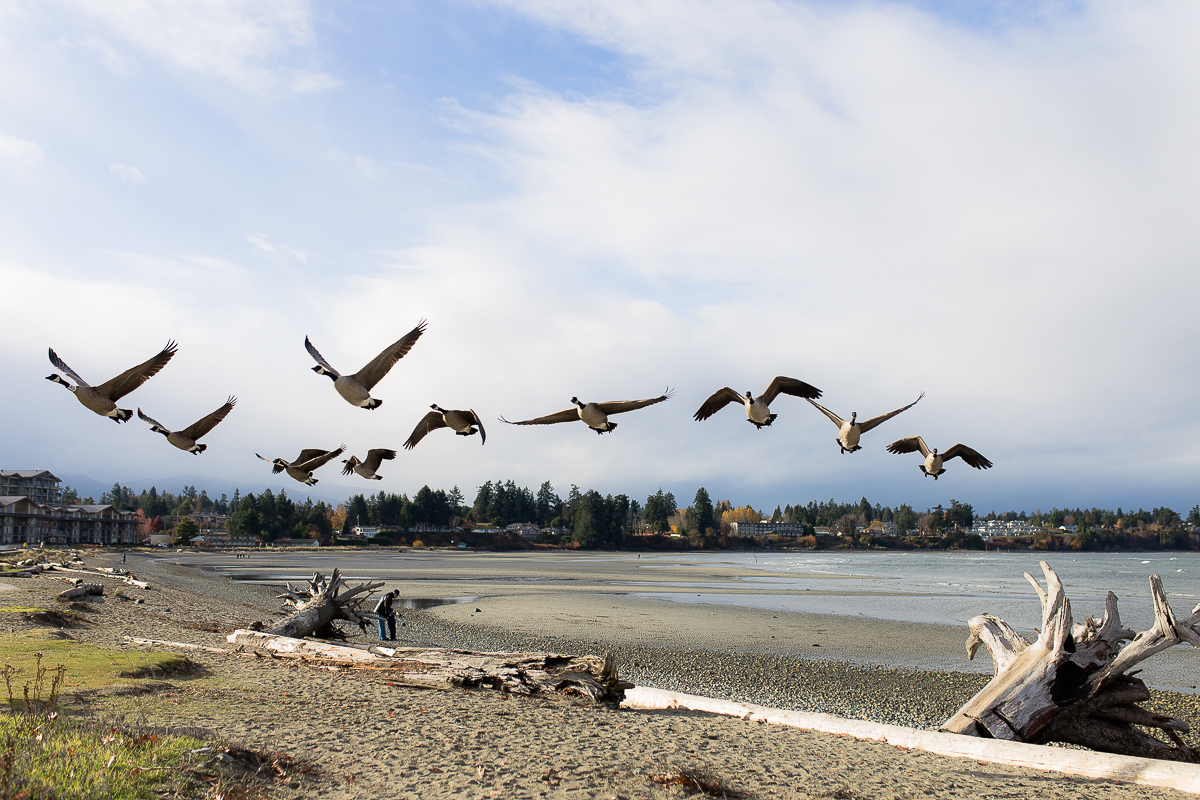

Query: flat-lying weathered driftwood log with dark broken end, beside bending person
left=227, top=630, right=634, bottom=703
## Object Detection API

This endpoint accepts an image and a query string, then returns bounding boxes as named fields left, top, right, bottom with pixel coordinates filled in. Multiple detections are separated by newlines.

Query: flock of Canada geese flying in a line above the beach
left=47, top=319, right=991, bottom=486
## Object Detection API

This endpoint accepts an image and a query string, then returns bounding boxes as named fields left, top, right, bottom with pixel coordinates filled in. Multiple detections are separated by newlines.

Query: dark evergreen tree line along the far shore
left=62, top=480, right=1200, bottom=549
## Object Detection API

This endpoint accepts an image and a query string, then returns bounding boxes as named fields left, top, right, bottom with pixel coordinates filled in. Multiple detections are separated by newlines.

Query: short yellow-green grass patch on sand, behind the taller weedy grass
left=0, top=631, right=201, bottom=693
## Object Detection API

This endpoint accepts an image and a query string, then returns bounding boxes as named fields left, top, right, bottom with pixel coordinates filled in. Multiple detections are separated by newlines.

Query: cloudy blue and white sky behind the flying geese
left=0, top=0, right=1200, bottom=513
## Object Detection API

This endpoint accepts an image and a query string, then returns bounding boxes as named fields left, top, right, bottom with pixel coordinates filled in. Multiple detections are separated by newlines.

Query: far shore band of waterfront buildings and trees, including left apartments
left=0, top=469, right=1200, bottom=549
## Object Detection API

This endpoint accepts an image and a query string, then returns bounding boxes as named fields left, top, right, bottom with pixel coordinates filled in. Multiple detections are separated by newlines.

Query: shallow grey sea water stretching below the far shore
left=170, top=551, right=1200, bottom=630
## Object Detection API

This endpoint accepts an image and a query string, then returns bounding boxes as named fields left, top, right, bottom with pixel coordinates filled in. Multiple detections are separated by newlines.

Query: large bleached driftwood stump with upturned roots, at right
left=942, top=561, right=1200, bottom=763
